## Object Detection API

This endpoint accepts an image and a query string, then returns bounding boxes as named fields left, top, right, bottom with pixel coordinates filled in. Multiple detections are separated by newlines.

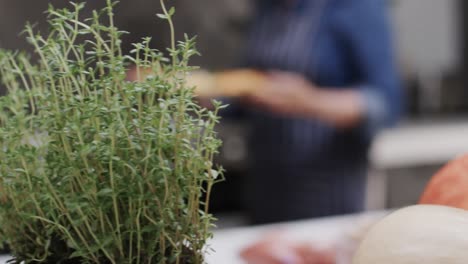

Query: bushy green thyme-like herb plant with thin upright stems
left=0, top=0, right=222, bottom=264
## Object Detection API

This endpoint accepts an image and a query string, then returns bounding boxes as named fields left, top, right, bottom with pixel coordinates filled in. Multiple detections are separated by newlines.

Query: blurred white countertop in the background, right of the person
left=370, top=118, right=468, bottom=169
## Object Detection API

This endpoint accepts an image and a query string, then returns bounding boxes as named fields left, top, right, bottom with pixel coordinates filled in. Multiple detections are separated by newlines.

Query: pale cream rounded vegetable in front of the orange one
left=353, top=204, right=468, bottom=264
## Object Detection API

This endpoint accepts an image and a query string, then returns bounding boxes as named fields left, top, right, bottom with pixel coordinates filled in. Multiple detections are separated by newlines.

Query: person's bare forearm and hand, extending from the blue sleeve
left=248, top=72, right=365, bottom=127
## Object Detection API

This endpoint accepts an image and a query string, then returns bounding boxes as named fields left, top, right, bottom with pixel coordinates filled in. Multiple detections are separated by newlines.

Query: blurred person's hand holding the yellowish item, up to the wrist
left=245, top=71, right=317, bottom=116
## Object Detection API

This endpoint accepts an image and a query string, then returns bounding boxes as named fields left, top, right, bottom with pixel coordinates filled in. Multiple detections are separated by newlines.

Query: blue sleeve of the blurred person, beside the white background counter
left=341, top=0, right=402, bottom=138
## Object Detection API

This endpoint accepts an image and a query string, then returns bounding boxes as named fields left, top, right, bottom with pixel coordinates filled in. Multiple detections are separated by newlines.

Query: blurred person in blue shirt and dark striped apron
left=229, top=0, right=401, bottom=224
